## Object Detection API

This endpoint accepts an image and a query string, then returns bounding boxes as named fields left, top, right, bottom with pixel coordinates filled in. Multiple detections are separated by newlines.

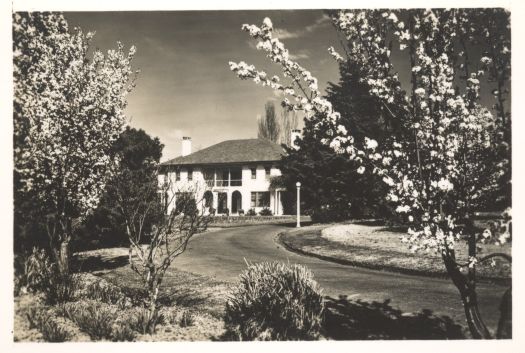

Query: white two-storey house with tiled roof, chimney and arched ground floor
left=159, top=137, right=284, bottom=215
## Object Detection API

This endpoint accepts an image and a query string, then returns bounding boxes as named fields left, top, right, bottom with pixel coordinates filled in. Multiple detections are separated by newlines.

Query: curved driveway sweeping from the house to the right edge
left=173, top=225, right=505, bottom=328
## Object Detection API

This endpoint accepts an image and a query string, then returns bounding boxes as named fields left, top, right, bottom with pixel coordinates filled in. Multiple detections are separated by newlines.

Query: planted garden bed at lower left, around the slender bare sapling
left=14, top=248, right=229, bottom=342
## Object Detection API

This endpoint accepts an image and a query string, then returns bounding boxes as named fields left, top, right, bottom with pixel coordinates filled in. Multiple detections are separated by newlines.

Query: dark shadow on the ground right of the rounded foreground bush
left=323, top=296, right=466, bottom=340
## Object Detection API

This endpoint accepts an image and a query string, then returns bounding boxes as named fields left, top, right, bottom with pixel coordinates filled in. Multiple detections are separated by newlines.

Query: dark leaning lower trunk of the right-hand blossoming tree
left=443, top=255, right=492, bottom=339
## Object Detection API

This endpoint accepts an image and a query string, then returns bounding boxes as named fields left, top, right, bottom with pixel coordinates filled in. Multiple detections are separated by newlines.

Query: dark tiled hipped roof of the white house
left=162, top=139, right=284, bottom=165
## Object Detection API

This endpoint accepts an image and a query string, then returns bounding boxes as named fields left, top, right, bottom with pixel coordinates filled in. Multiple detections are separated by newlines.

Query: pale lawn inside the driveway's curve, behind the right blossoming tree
left=280, top=224, right=511, bottom=282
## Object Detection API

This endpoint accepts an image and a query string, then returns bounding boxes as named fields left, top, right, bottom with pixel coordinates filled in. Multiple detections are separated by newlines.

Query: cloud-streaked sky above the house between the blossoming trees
left=65, top=10, right=339, bottom=161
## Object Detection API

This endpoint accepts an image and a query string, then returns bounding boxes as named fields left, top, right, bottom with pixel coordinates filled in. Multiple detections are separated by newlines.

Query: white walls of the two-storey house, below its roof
left=159, top=164, right=283, bottom=215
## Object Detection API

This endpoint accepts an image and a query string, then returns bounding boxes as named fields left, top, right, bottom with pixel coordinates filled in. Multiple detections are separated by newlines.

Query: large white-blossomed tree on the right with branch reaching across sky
left=230, top=9, right=511, bottom=338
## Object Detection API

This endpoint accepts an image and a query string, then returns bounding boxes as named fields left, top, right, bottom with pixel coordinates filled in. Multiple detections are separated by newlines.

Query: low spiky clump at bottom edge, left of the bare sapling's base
left=58, top=300, right=119, bottom=340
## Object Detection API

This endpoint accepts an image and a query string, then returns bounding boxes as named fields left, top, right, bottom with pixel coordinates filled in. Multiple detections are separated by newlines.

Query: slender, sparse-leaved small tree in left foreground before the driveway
left=110, top=164, right=210, bottom=332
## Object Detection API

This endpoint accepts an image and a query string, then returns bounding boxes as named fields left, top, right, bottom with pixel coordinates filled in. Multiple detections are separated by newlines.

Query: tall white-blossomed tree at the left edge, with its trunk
left=13, top=12, right=135, bottom=273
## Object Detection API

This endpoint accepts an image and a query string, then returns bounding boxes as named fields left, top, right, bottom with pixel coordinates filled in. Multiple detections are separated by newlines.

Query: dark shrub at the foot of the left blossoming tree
left=24, top=248, right=75, bottom=304
